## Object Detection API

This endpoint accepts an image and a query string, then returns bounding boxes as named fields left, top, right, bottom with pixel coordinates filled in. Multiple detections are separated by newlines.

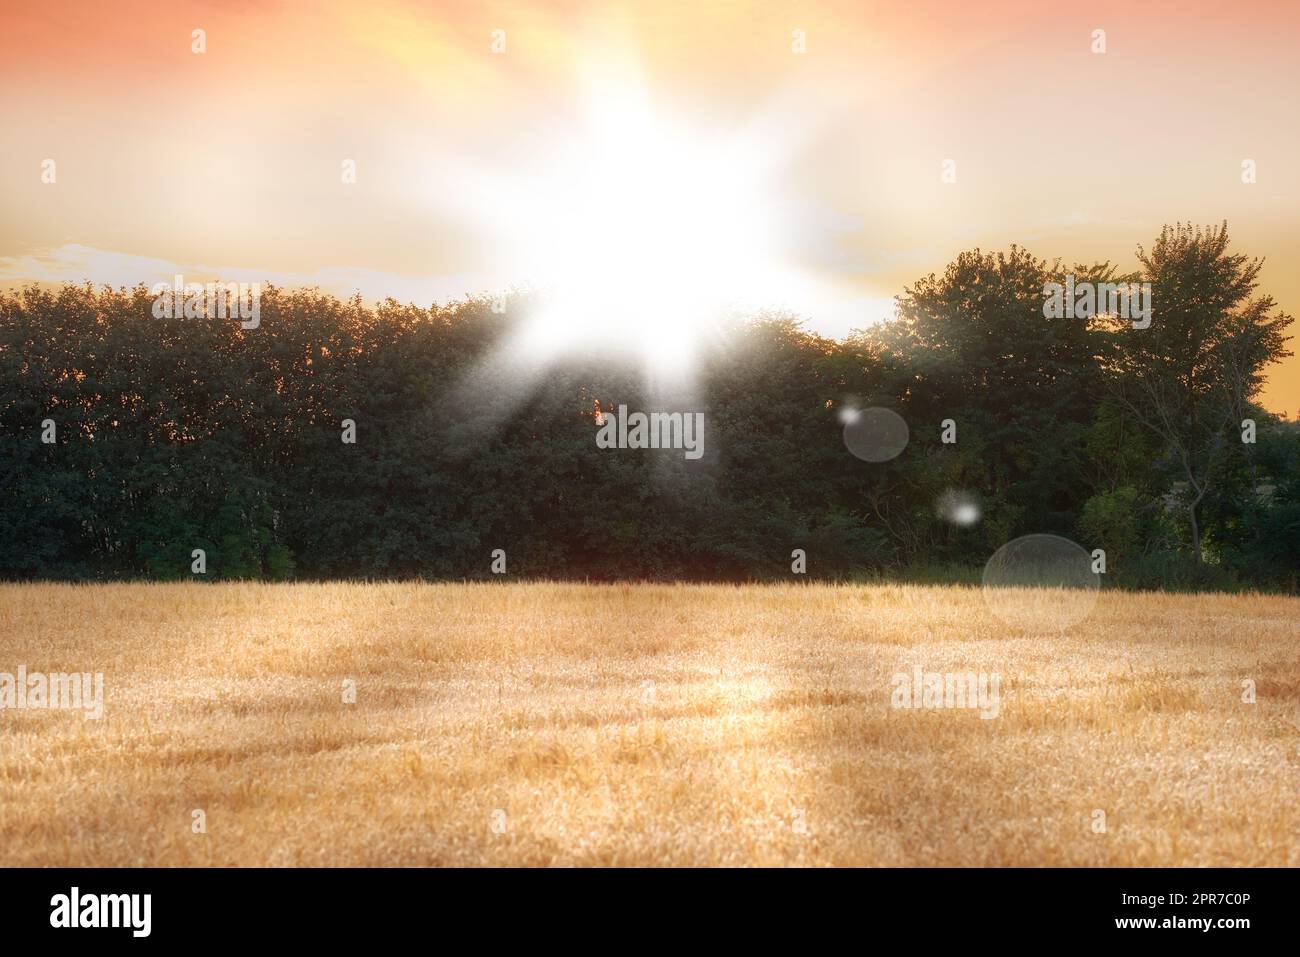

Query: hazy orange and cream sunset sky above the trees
left=0, top=0, right=1300, bottom=416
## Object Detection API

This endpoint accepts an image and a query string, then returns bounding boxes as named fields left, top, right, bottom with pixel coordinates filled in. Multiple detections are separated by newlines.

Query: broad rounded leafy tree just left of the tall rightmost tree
left=850, top=246, right=1102, bottom=555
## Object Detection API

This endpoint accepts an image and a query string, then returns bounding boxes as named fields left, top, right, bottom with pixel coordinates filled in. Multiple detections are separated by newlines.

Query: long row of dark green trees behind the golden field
left=0, top=225, right=1300, bottom=592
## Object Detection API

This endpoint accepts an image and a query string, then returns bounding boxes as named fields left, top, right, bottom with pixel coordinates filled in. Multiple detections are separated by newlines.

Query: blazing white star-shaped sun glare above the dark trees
left=431, top=58, right=800, bottom=377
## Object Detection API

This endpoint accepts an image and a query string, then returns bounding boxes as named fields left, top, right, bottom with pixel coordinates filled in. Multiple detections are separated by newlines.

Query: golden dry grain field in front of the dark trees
left=0, top=584, right=1300, bottom=866
